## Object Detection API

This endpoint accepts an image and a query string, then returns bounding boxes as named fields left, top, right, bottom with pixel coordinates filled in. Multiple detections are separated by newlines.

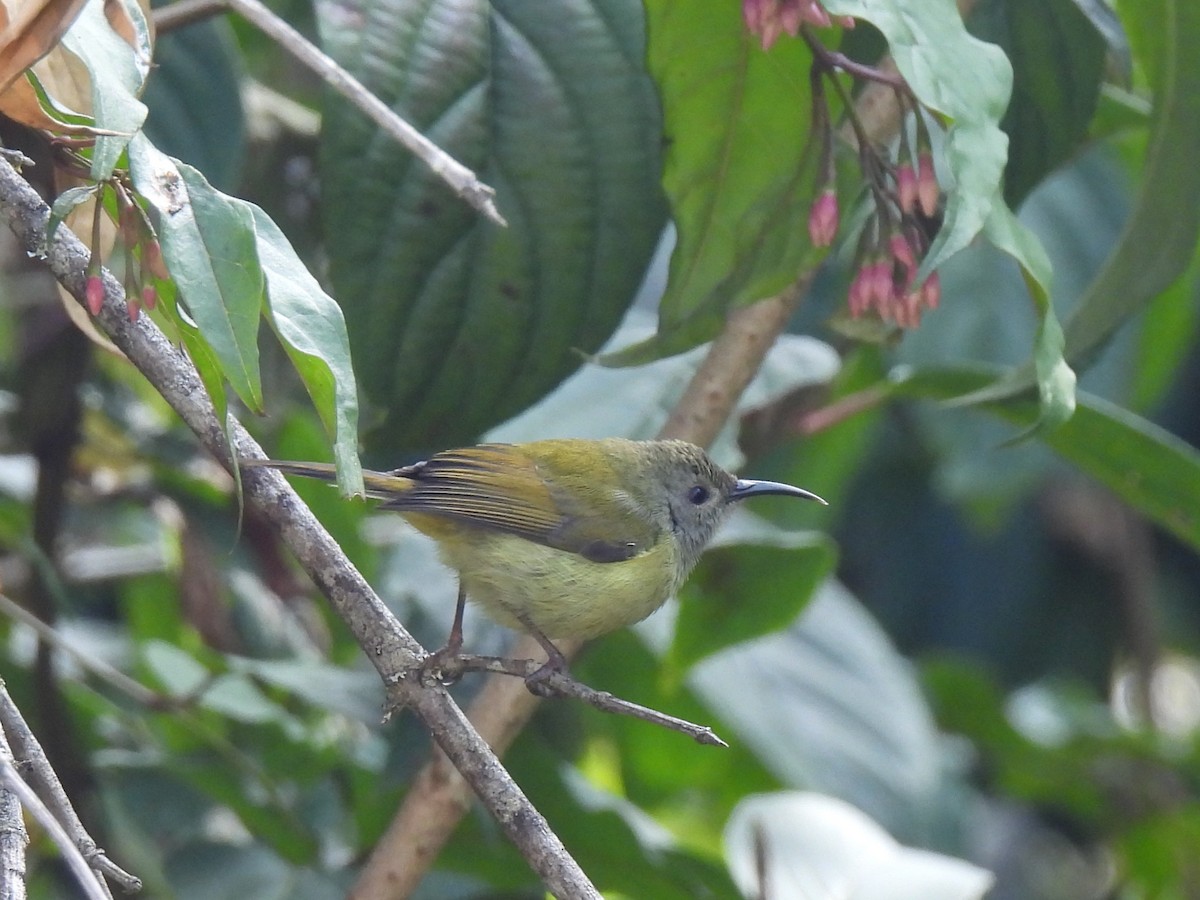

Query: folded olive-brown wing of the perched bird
left=383, top=444, right=658, bottom=563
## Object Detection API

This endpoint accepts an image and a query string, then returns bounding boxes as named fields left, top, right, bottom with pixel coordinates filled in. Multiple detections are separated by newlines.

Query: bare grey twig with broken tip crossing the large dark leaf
left=155, top=0, right=508, bottom=226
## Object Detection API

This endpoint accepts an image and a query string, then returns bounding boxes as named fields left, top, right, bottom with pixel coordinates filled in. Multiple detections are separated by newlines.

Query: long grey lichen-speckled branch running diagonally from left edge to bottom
left=0, top=161, right=600, bottom=900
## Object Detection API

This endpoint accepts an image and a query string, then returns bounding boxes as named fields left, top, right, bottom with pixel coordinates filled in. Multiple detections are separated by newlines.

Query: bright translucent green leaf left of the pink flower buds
left=605, top=0, right=817, bottom=365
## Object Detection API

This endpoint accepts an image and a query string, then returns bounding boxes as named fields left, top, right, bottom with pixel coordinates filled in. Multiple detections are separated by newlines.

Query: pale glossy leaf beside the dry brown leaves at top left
left=62, top=0, right=150, bottom=181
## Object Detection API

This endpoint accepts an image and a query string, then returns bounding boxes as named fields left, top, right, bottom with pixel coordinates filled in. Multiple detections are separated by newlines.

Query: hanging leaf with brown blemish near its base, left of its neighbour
left=130, top=136, right=265, bottom=413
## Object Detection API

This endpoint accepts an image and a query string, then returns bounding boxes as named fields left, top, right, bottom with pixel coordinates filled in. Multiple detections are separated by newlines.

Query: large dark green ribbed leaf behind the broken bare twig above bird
left=323, top=0, right=665, bottom=457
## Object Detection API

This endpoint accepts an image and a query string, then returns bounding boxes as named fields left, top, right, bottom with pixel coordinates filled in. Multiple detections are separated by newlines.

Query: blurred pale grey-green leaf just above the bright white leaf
left=688, top=582, right=943, bottom=840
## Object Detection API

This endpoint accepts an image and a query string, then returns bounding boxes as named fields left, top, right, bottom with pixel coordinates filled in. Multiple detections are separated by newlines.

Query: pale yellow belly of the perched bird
left=440, top=534, right=679, bottom=640
